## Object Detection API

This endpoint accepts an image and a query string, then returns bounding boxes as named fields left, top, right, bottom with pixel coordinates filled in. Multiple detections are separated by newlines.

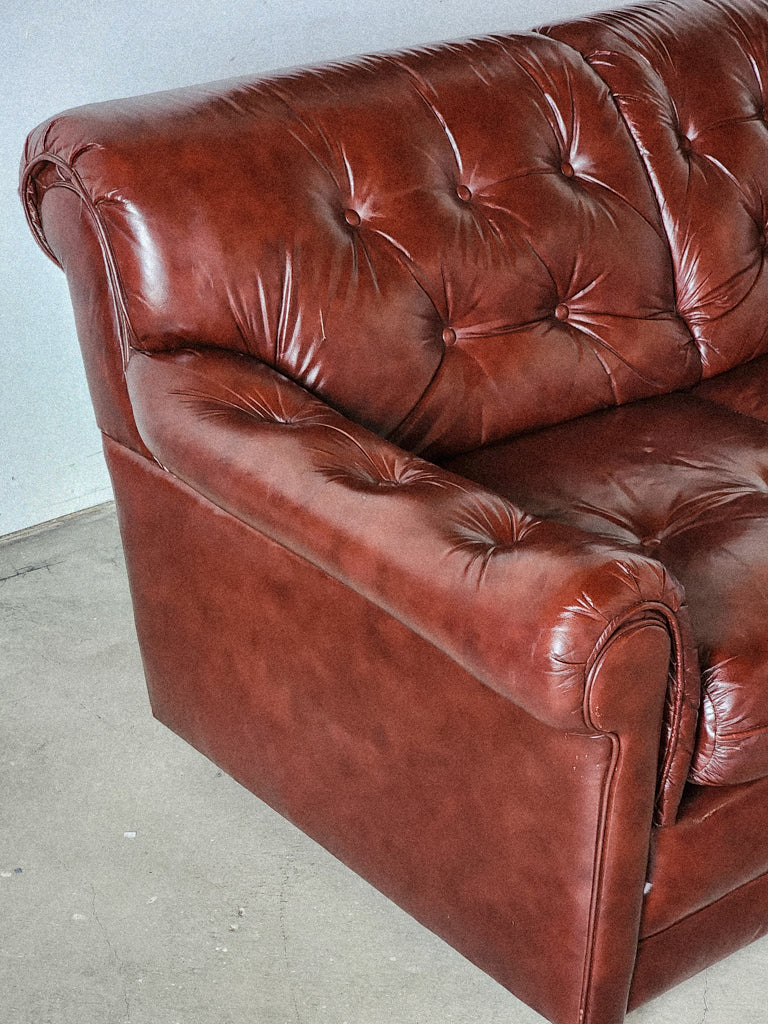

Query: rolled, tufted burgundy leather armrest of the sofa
left=126, top=349, right=698, bottom=817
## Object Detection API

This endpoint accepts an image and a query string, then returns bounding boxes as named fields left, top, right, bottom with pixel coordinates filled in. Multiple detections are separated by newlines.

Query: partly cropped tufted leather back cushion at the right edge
left=545, top=0, right=768, bottom=377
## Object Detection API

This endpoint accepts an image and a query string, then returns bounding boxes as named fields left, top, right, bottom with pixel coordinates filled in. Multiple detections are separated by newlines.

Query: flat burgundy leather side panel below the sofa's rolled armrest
left=105, top=439, right=669, bottom=1024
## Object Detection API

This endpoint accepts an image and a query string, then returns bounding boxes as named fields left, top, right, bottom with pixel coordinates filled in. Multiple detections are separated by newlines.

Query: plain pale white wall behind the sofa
left=0, top=0, right=610, bottom=535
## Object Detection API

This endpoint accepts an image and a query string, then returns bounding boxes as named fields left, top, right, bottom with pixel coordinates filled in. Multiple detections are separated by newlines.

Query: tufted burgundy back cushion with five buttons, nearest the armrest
left=32, top=36, right=700, bottom=456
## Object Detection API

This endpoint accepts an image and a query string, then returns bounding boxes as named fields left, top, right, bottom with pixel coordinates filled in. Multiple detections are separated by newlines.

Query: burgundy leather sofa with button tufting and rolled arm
left=22, top=0, right=768, bottom=1024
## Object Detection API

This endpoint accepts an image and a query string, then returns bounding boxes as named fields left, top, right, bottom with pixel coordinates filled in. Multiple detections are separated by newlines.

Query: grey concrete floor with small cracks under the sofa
left=0, top=506, right=768, bottom=1024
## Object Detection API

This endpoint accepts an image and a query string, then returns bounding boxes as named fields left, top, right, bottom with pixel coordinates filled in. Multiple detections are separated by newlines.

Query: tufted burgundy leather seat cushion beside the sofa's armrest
left=446, top=394, right=768, bottom=784
